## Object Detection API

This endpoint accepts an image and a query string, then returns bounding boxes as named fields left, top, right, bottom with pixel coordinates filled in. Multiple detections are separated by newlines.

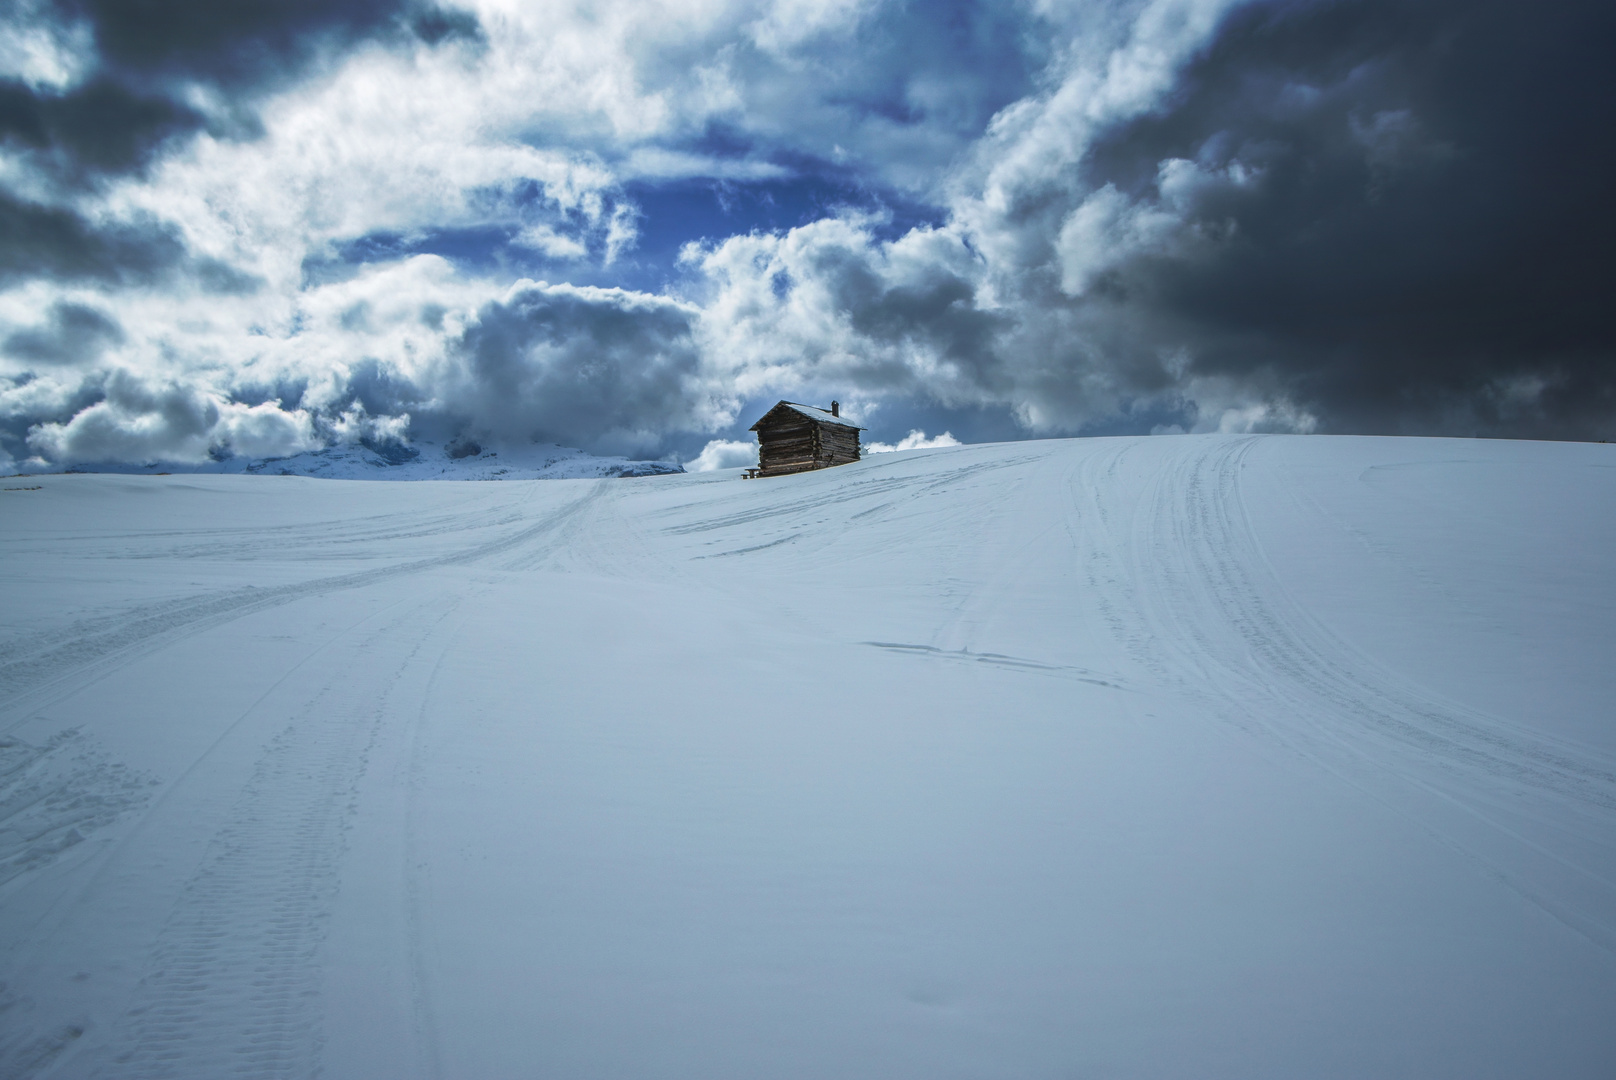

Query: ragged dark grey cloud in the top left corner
left=0, top=0, right=478, bottom=307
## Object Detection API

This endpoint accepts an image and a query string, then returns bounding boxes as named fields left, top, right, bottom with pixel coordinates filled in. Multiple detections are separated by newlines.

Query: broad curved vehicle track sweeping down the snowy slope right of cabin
left=1112, top=437, right=1616, bottom=949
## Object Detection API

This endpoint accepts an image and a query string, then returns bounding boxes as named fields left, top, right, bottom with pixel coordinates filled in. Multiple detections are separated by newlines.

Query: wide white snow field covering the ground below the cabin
left=0, top=437, right=1616, bottom=1080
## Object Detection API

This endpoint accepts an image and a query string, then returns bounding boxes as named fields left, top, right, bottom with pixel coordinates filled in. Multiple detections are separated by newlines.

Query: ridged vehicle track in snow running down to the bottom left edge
left=100, top=600, right=454, bottom=1080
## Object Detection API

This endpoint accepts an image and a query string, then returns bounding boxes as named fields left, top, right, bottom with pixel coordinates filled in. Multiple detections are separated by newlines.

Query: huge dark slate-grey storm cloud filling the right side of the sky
left=1086, top=0, right=1616, bottom=437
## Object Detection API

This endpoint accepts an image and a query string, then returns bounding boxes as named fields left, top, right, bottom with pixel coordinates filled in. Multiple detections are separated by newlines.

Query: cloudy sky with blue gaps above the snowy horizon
left=0, top=0, right=1616, bottom=470
